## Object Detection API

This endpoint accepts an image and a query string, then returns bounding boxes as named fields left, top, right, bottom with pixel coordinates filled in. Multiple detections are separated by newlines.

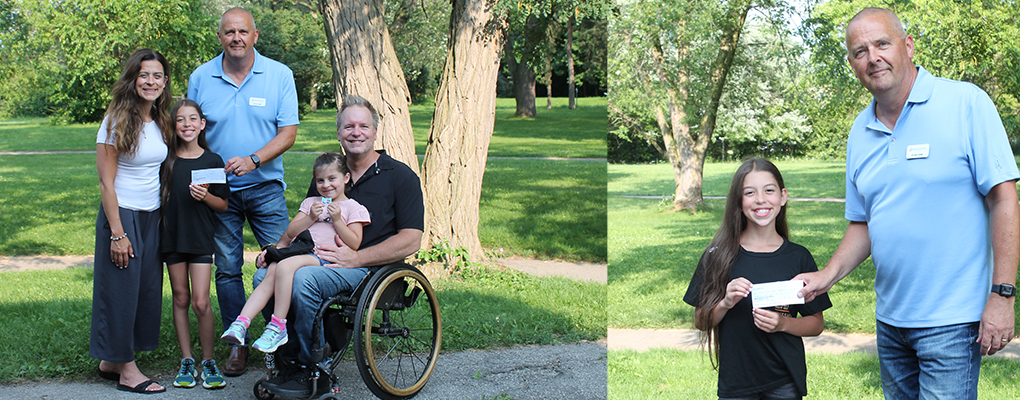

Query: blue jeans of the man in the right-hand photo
left=877, top=321, right=981, bottom=400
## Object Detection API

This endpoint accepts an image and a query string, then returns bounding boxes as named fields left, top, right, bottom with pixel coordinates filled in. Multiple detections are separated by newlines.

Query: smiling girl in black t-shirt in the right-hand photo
left=683, top=158, right=831, bottom=399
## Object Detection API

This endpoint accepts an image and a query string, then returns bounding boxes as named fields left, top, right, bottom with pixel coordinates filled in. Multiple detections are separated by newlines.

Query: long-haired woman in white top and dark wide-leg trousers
left=89, top=49, right=173, bottom=393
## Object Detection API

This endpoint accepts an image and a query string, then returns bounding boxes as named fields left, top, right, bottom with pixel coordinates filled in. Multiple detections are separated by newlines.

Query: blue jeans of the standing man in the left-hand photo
left=214, top=181, right=290, bottom=336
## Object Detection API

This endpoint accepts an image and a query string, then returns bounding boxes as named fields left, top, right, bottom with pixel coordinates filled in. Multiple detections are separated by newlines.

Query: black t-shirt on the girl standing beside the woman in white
left=159, top=150, right=231, bottom=255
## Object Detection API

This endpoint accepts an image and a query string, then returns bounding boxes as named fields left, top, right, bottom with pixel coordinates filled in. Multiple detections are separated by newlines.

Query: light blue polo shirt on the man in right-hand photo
left=846, top=66, right=1020, bottom=328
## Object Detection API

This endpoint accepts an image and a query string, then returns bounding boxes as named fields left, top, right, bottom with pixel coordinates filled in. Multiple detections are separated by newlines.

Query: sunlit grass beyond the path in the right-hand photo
left=607, top=161, right=1020, bottom=334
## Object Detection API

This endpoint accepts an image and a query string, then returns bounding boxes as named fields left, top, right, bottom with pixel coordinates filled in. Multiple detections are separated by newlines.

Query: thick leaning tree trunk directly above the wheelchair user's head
left=320, top=0, right=418, bottom=173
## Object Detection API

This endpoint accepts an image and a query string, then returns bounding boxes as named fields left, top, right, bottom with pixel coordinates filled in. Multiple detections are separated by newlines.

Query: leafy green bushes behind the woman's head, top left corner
left=0, top=0, right=216, bottom=121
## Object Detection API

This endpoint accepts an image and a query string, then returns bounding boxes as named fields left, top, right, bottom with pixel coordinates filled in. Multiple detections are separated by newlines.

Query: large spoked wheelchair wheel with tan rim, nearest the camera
left=354, top=265, right=442, bottom=399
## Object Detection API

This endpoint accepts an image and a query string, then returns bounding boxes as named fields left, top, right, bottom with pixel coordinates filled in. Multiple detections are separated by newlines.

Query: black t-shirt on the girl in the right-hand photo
left=683, top=241, right=832, bottom=397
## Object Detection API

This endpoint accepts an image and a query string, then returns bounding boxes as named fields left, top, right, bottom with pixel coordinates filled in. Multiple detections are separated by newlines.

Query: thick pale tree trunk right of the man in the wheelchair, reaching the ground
left=422, top=0, right=505, bottom=260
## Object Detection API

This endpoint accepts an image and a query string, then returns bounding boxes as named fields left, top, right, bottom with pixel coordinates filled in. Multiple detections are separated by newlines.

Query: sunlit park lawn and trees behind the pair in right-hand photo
left=607, top=0, right=1020, bottom=399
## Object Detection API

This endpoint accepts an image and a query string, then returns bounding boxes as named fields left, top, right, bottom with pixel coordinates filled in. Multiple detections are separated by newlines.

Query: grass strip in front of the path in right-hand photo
left=608, top=349, right=1020, bottom=400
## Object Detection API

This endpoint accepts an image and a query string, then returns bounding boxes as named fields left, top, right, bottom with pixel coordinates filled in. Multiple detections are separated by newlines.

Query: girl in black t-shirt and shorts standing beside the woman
left=160, top=99, right=231, bottom=389
